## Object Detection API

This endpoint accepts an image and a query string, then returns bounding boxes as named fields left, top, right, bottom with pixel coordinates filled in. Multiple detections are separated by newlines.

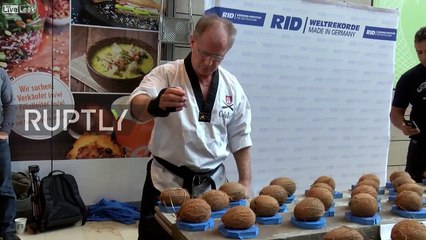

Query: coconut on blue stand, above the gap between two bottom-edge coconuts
left=349, top=193, right=378, bottom=217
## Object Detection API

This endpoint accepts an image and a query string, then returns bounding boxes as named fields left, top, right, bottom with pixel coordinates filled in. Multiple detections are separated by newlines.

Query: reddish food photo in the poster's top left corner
left=0, top=0, right=69, bottom=84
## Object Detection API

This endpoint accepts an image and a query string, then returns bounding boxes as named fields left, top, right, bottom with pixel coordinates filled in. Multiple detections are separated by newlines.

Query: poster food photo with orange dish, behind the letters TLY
left=66, top=93, right=153, bottom=159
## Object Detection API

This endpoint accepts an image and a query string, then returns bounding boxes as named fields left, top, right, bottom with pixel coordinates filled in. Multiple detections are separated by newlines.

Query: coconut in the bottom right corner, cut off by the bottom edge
left=391, top=219, right=426, bottom=240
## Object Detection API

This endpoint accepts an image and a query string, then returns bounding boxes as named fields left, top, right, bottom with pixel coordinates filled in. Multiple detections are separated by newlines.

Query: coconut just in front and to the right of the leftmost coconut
left=176, top=198, right=211, bottom=223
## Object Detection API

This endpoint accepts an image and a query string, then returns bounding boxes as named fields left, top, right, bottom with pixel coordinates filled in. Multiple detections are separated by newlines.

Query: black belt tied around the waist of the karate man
left=154, top=156, right=221, bottom=195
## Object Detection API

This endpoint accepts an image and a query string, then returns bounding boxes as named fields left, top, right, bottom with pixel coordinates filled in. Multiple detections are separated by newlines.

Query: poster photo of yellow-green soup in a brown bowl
left=70, top=26, right=157, bottom=93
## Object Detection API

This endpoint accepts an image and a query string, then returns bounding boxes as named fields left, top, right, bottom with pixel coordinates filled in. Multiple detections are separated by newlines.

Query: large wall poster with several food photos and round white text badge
left=0, top=0, right=161, bottom=161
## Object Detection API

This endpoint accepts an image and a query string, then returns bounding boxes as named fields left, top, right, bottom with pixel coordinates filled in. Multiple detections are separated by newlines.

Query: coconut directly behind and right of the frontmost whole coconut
left=250, top=195, right=280, bottom=217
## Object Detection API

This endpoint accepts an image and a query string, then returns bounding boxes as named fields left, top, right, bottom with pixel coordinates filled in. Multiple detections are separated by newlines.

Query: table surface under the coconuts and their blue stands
left=155, top=191, right=425, bottom=240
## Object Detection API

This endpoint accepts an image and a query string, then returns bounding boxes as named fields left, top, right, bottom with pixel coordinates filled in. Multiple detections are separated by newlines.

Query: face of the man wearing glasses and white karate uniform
left=191, top=28, right=228, bottom=77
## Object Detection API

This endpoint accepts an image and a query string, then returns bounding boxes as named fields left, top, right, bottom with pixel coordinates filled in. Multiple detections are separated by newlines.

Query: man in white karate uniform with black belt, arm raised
left=130, top=15, right=252, bottom=239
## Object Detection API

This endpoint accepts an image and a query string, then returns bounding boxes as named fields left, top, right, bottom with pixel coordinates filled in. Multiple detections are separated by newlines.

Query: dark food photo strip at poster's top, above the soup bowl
left=71, top=0, right=161, bottom=31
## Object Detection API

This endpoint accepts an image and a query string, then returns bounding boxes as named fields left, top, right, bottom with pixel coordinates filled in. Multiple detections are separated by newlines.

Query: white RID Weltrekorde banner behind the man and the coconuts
left=205, top=0, right=398, bottom=195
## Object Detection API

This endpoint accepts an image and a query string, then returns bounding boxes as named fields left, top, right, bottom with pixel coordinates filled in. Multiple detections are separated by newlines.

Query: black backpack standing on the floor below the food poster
left=37, top=170, right=87, bottom=231
